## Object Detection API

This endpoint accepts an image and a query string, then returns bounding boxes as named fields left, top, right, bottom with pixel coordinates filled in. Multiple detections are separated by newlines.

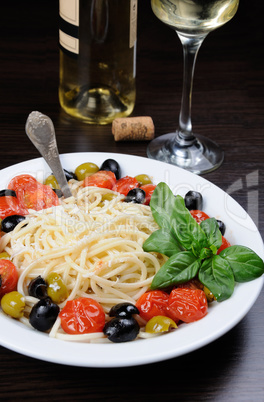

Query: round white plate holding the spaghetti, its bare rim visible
left=0, top=153, right=264, bottom=367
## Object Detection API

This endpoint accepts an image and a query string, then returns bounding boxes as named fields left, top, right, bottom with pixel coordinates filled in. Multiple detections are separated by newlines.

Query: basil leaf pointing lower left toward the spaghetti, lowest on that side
left=151, top=251, right=201, bottom=289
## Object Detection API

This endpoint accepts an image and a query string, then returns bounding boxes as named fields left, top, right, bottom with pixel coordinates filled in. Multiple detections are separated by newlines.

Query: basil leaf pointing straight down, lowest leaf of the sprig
left=198, top=255, right=235, bottom=301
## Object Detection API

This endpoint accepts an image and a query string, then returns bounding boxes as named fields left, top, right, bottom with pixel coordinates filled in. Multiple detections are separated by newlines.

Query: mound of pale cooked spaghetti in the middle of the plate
left=1, top=180, right=167, bottom=341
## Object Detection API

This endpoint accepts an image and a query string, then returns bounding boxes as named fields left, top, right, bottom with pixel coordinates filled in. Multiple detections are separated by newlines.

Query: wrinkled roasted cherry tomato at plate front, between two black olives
left=59, top=297, right=105, bottom=334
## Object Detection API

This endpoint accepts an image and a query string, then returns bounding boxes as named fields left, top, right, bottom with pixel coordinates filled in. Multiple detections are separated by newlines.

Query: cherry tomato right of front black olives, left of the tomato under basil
left=136, top=290, right=169, bottom=321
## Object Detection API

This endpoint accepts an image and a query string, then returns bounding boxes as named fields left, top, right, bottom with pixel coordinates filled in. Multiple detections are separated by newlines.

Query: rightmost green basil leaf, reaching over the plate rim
left=219, top=246, right=264, bottom=282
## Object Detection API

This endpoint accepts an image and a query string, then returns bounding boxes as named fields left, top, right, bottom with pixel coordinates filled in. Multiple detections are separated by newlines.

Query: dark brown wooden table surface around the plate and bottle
left=0, top=0, right=264, bottom=402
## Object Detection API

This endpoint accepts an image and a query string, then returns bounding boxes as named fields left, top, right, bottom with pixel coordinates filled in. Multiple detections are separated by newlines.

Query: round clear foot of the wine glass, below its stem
left=147, top=132, right=224, bottom=174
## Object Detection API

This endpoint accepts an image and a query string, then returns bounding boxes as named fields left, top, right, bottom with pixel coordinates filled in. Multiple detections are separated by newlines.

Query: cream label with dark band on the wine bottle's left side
left=59, top=0, right=79, bottom=55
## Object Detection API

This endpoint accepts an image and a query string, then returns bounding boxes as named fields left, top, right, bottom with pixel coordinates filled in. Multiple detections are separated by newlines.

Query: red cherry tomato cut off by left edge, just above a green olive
left=0, top=259, right=18, bottom=297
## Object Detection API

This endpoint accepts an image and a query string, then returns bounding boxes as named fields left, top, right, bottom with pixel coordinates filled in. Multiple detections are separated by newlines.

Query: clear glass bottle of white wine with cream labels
left=59, top=0, right=138, bottom=124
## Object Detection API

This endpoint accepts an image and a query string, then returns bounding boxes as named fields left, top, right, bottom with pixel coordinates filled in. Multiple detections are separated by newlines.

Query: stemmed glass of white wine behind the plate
left=147, top=0, right=239, bottom=174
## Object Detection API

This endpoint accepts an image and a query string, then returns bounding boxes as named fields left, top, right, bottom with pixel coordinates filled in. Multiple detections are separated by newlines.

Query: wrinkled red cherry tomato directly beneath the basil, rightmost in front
left=168, top=288, right=208, bottom=322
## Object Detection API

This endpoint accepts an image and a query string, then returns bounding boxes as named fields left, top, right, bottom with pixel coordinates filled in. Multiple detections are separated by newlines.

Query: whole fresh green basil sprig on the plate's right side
left=143, top=183, right=264, bottom=301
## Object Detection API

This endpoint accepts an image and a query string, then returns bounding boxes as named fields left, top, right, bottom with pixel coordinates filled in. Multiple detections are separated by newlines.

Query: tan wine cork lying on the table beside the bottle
left=112, top=116, right=155, bottom=141
